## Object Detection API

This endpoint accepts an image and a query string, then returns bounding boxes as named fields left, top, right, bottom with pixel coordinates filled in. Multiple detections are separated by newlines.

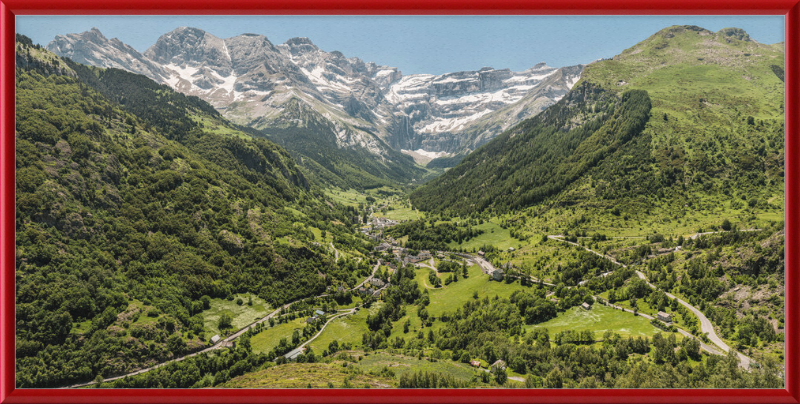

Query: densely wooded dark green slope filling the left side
left=16, top=38, right=367, bottom=387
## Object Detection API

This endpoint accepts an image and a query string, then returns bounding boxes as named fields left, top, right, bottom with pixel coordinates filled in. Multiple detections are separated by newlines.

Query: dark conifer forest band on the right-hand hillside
left=412, top=83, right=650, bottom=213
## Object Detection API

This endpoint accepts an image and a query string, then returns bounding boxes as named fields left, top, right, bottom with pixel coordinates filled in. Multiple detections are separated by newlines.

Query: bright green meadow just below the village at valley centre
left=416, top=265, right=526, bottom=317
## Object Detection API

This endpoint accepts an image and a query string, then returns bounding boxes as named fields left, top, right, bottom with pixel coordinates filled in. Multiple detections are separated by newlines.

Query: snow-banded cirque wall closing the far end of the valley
left=386, top=63, right=583, bottom=153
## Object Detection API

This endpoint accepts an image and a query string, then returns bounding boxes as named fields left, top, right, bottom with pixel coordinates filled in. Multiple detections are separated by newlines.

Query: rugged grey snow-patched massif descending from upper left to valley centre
left=49, top=27, right=425, bottom=188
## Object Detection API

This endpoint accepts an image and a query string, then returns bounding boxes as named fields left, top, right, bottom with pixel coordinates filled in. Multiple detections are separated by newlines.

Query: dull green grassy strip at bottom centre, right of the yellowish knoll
left=356, top=352, right=476, bottom=381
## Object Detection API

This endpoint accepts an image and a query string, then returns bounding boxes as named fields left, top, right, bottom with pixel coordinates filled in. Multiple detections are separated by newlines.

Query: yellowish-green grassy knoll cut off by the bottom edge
left=219, top=361, right=397, bottom=388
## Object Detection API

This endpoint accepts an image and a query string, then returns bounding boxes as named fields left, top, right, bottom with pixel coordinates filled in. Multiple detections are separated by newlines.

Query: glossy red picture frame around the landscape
left=0, top=0, right=800, bottom=404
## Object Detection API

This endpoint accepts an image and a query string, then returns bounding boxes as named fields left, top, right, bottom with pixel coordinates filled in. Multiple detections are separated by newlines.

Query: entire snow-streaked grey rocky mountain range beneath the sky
left=47, top=27, right=583, bottom=161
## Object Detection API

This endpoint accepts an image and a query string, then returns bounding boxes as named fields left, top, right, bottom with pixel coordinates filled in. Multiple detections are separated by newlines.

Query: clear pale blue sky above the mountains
left=16, top=16, right=784, bottom=74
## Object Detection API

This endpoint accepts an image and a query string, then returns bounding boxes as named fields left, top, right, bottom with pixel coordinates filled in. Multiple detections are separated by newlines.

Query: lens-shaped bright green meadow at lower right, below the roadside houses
left=525, top=304, right=661, bottom=339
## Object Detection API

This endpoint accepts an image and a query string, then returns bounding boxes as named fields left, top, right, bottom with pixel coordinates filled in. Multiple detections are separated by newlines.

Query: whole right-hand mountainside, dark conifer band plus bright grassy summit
left=412, top=26, right=784, bottom=215
